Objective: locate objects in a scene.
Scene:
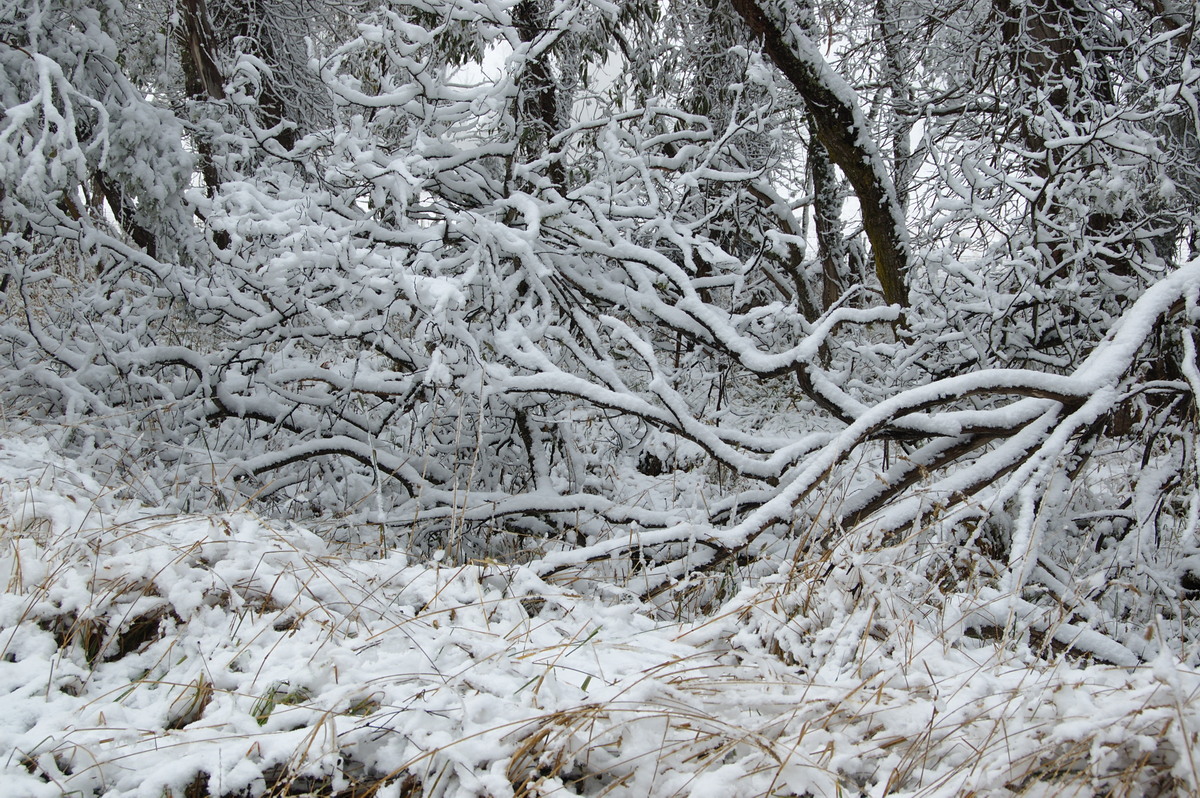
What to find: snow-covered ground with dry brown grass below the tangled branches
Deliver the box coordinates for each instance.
[0,437,1200,798]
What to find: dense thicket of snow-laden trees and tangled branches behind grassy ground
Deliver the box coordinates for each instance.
[0,0,1200,661]
